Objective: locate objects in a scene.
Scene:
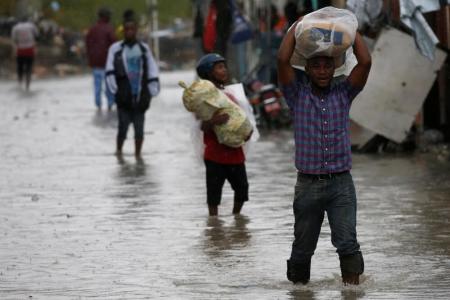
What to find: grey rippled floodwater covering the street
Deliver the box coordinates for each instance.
[0,72,450,299]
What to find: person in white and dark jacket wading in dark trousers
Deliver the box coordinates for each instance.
[106,11,160,158]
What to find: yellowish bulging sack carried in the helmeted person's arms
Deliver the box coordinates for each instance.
[179,79,253,148]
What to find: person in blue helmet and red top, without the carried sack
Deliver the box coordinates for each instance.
[197,53,248,216]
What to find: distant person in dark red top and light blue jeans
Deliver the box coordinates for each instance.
[86,8,116,110]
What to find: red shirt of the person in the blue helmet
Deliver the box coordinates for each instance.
[203,93,245,165]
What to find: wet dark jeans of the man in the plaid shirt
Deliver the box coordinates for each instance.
[288,172,364,282]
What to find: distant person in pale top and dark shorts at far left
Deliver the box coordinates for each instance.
[11,18,38,90]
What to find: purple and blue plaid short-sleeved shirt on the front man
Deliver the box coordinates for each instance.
[281,71,360,174]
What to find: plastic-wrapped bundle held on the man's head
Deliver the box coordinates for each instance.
[291,6,358,68]
